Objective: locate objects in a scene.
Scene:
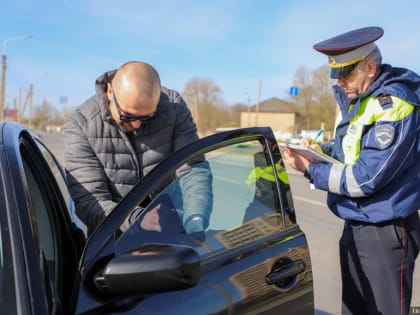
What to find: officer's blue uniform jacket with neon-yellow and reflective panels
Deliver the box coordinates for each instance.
[308,65,420,223]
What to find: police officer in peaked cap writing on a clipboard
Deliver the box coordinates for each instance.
[285,27,420,315]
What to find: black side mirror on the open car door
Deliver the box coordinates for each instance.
[94,244,200,295]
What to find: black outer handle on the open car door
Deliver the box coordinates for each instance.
[265,259,305,286]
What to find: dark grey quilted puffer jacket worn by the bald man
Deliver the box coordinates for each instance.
[64,70,205,231]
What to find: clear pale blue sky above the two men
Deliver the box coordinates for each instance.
[0,0,420,109]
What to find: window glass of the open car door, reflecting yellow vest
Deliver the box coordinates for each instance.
[116,141,288,257]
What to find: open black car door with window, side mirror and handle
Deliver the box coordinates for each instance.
[75,128,314,315]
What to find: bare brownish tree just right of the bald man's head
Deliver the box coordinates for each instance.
[182,78,230,135]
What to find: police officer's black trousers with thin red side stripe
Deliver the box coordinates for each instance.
[340,212,420,315]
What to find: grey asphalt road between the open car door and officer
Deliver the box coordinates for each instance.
[41,133,420,315]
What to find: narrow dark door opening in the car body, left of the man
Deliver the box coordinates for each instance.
[20,135,84,310]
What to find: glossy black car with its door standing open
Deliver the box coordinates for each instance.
[0,122,314,315]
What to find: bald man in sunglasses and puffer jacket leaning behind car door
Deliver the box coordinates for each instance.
[64,61,212,234]
